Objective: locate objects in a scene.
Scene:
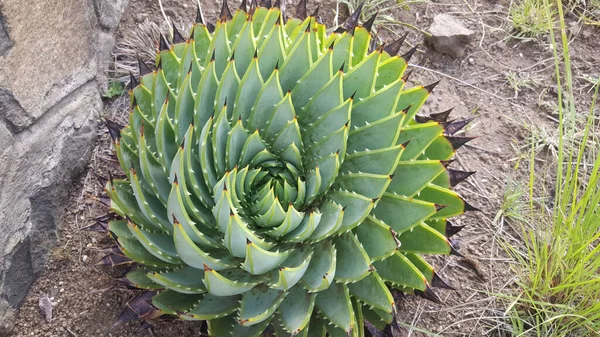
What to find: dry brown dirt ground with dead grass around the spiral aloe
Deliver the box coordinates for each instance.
[14,0,600,337]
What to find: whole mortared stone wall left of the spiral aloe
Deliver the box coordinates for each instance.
[0,0,128,335]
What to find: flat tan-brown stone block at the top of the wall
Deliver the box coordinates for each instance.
[0,0,97,122]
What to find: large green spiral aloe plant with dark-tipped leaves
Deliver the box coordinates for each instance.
[102,1,472,337]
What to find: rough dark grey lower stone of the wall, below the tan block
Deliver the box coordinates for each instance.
[0,83,102,332]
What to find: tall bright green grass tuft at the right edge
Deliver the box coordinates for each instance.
[499,0,600,337]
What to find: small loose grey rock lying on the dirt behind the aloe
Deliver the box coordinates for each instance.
[426,14,474,57]
